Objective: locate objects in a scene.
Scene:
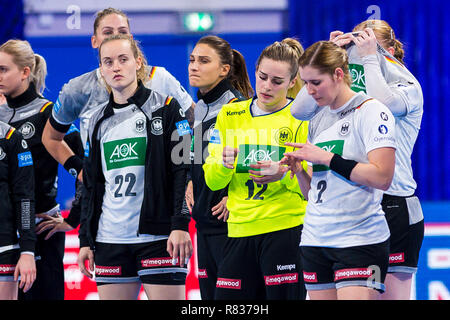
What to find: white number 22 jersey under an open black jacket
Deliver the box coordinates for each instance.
[96,105,167,243]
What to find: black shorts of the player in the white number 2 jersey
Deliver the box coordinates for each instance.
[300,240,389,292]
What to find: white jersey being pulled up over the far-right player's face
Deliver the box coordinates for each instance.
[348,45,423,197]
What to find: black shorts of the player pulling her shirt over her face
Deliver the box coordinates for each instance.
[381,194,425,273]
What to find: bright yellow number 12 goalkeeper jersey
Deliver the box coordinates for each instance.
[203,99,308,237]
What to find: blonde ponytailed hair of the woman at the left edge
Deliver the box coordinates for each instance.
[0,39,47,95]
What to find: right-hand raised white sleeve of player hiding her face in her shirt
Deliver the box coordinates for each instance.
[362,54,408,117]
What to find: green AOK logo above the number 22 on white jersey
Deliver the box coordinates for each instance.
[103,137,147,170]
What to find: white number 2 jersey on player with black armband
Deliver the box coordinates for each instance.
[301,93,395,248]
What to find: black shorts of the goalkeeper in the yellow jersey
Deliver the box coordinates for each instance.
[215,226,306,300]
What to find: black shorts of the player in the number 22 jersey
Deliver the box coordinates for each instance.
[94,240,187,285]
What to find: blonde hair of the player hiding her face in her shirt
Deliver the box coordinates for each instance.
[353,19,405,64]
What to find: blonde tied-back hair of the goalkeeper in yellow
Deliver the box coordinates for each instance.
[256,38,304,98]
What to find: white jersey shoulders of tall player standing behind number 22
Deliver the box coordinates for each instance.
[52,67,193,146]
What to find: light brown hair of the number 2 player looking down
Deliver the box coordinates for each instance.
[299,41,352,86]
